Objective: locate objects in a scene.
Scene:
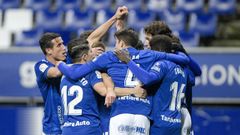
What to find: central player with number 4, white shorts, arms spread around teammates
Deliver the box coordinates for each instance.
[58,29,188,135]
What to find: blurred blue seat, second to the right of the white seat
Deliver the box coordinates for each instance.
[65,9,94,30]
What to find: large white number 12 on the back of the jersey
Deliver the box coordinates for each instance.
[61,85,83,115]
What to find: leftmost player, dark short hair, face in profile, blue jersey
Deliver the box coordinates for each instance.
[34,33,66,135]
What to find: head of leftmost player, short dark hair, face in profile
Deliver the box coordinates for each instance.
[39,33,66,61]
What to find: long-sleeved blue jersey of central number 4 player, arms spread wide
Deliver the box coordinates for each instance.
[58,48,189,116]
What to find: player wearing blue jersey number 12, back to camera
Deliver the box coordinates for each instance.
[61,40,146,135]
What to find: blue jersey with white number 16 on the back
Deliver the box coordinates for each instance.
[150,60,188,135]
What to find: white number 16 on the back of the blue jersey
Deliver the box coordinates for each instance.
[169,81,185,111]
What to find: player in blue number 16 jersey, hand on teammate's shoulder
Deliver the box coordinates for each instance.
[116,35,187,135]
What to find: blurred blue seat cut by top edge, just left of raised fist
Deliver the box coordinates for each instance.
[85,0,112,11]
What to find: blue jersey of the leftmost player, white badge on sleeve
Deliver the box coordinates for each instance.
[34,59,63,134]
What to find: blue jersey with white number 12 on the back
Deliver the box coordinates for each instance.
[60,64,102,135]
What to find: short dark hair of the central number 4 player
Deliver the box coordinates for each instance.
[115,29,139,48]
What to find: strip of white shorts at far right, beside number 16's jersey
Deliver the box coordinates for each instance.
[181,107,192,135]
